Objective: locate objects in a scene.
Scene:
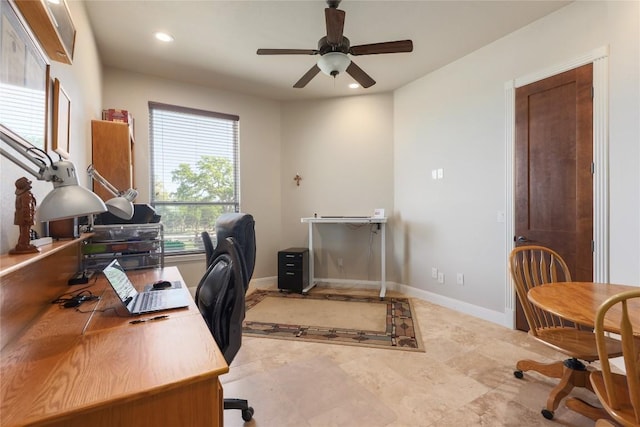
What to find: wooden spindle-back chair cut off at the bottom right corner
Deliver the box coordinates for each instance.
[590,288,640,427]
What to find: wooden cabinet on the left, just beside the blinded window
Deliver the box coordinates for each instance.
[91,120,134,201]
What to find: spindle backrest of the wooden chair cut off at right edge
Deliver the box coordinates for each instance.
[595,289,640,425]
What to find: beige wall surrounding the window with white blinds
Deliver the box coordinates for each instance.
[102,68,281,286]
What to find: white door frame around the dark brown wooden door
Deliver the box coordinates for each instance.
[503,46,609,329]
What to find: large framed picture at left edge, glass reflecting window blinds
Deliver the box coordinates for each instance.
[0,0,49,151]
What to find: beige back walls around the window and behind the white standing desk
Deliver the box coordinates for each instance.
[103,76,393,286]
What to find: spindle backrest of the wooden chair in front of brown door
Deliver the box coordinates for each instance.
[509,245,573,336]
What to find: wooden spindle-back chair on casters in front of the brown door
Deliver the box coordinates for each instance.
[509,245,622,420]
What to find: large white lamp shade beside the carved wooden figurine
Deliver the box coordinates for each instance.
[38,160,107,222]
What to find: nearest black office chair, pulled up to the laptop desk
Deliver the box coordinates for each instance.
[195,214,255,421]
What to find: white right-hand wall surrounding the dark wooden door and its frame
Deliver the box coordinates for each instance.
[394,1,640,320]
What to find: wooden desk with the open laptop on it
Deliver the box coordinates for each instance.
[0,267,229,427]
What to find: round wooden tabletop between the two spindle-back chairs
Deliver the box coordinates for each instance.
[527,282,640,333]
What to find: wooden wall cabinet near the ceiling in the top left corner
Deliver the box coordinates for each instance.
[15,0,76,64]
